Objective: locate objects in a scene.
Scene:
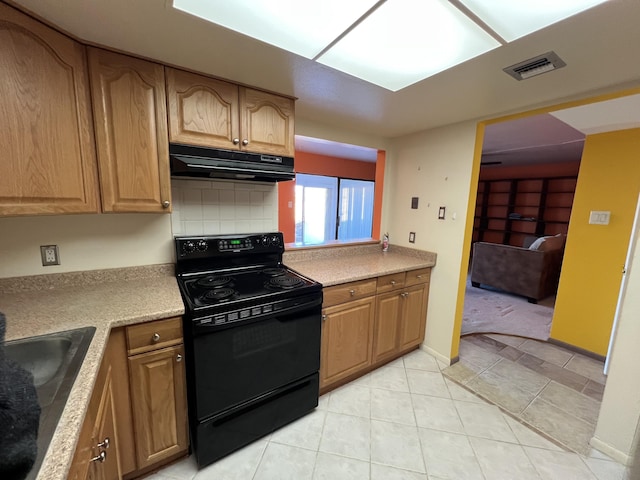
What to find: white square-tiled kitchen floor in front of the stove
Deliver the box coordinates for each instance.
[148,350,627,480]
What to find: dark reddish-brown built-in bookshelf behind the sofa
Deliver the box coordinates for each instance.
[473,176,577,246]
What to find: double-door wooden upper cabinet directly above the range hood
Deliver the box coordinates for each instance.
[166,67,294,156]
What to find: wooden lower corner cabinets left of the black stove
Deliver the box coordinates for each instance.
[68,317,189,480]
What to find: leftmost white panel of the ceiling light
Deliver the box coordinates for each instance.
[173,0,376,58]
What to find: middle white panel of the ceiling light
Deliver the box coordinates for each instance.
[317,0,500,92]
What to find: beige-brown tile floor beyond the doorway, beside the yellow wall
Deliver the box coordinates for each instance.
[443,334,606,455]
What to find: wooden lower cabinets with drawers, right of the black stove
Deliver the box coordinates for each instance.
[320,268,431,393]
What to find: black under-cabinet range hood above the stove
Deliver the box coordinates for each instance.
[169,143,295,182]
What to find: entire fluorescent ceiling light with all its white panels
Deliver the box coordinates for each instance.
[173,0,606,91]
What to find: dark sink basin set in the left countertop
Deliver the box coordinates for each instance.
[4,327,96,480]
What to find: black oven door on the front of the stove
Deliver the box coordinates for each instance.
[190,293,322,421]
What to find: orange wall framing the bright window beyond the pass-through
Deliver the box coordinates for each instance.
[278,152,384,243]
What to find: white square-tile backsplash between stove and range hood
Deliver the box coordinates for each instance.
[171,178,278,235]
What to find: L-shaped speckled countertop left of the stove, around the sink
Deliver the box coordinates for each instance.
[0,265,184,480]
